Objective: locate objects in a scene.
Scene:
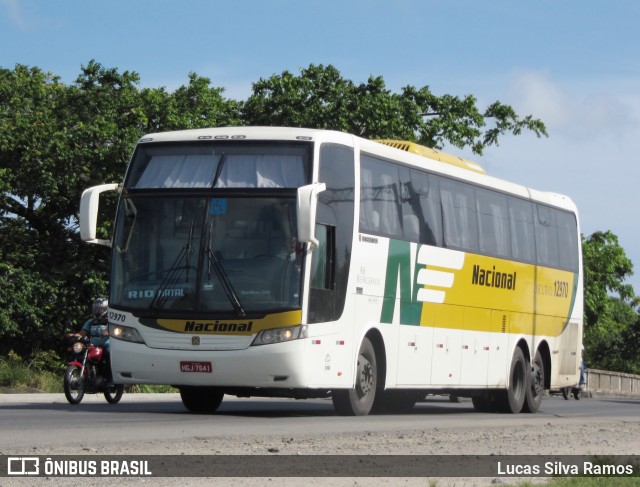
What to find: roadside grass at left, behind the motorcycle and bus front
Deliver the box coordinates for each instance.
[0,350,177,394]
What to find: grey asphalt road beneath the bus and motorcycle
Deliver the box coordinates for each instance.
[0,394,640,454]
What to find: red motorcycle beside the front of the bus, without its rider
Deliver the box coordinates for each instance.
[64,335,124,404]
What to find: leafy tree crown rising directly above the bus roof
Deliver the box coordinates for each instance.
[242,65,547,154]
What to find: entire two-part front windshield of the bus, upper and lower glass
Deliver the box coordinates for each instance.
[111,141,311,317]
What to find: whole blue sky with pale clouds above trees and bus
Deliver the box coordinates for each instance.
[0,0,640,294]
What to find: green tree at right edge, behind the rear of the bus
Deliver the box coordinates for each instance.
[582,231,640,372]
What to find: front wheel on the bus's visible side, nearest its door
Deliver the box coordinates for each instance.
[331,337,378,416]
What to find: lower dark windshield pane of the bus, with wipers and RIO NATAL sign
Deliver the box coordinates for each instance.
[111,195,301,317]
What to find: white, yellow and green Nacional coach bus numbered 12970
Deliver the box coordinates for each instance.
[80,127,583,415]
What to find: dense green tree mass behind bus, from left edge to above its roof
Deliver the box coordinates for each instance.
[0,61,560,354]
